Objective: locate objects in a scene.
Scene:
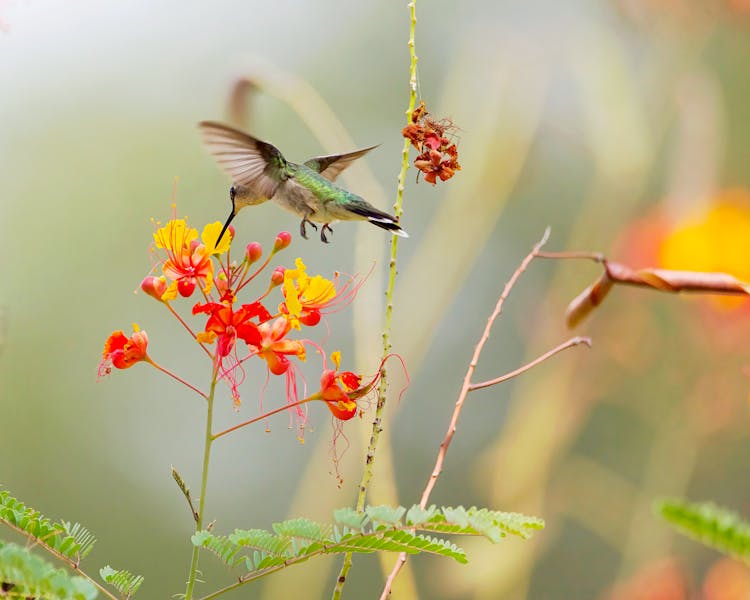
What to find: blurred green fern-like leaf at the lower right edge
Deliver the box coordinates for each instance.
[656,500,750,564]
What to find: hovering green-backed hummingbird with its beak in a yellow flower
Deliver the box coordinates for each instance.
[198,121,409,244]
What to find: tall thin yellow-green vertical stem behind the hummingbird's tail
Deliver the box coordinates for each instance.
[332,0,418,600]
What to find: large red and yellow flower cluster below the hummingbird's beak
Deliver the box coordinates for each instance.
[99,207,377,427]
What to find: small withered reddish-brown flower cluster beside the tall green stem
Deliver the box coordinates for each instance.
[401,102,461,185]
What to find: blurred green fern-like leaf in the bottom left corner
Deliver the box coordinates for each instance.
[0,542,97,600]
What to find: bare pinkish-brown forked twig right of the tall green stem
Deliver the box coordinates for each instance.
[380,227,585,600]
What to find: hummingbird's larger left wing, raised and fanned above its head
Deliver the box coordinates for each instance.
[198,121,289,198]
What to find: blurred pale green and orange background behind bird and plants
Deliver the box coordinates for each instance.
[0,0,750,599]
